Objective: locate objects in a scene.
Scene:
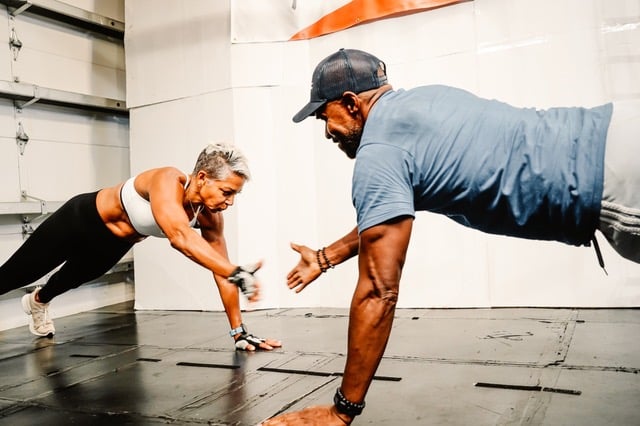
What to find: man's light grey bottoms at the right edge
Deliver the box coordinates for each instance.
[598,100,640,263]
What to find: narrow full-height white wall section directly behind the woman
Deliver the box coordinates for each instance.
[125,0,240,310]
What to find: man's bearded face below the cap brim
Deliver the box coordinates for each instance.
[316,100,363,158]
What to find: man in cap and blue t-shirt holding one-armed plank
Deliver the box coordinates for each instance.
[264,49,640,426]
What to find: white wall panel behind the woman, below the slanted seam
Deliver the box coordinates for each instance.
[131,90,244,310]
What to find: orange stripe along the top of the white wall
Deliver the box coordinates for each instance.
[289,0,472,40]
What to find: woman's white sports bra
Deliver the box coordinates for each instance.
[120,173,202,238]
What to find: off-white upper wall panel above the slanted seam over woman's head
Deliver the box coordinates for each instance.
[125,0,230,108]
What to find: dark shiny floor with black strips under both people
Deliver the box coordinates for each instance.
[0,303,640,426]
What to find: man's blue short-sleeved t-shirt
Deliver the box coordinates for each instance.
[352,86,612,245]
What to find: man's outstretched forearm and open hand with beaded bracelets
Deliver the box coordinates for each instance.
[287,227,359,293]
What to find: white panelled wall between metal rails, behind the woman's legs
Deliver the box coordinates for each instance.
[0,0,133,329]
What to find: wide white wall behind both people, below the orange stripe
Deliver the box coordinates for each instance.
[125,0,640,309]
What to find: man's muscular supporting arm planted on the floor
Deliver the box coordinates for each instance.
[263,216,413,426]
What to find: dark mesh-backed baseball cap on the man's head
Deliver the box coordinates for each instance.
[293,48,387,123]
